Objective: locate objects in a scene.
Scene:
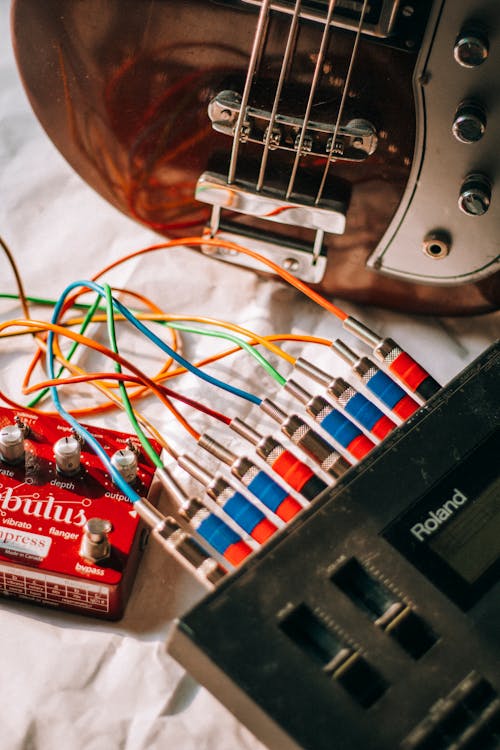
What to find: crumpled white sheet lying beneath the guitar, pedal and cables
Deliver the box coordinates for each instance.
[0,5,499,750]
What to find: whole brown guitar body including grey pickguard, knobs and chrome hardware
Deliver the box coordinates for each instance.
[12,0,500,314]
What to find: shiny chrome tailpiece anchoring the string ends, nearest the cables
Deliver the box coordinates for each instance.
[195,172,347,284]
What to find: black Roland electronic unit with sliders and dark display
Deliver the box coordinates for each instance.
[169,344,500,750]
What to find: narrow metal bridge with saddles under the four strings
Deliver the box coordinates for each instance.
[208,91,378,162]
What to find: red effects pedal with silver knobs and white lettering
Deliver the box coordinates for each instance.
[0,408,159,619]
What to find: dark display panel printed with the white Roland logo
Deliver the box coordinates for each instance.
[384,429,500,612]
